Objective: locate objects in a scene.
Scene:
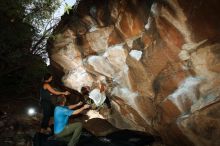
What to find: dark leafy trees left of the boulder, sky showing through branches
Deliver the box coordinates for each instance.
[0,0,60,97]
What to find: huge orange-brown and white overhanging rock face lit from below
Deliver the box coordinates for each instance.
[48,0,220,146]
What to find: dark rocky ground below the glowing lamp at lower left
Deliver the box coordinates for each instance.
[0,113,39,146]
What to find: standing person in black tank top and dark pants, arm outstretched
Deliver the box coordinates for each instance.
[40,73,70,134]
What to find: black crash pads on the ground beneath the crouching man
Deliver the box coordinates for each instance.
[33,129,155,146]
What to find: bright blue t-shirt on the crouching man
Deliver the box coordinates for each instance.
[54,106,73,134]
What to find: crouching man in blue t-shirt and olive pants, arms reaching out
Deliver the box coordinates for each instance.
[54,97,90,146]
